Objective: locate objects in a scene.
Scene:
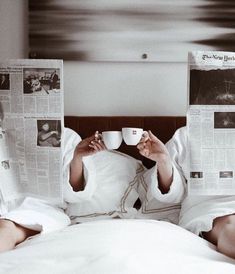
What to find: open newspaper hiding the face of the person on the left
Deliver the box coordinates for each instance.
[0,59,64,203]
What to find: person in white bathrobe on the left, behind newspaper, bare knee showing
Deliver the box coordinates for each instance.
[0,129,105,252]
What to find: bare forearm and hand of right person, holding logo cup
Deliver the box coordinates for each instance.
[137,131,173,193]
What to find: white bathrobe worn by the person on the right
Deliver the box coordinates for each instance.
[155,127,235,235]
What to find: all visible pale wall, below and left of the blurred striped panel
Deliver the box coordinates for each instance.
[0,0,187,115]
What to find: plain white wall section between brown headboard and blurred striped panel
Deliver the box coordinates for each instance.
[64,62,187,116]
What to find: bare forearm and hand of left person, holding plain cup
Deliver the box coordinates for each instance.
[69,132,105,191]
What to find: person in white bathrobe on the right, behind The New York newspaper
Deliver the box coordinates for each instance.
[138,127,235,258]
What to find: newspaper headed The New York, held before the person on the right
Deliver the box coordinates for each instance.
[187,51,235,195]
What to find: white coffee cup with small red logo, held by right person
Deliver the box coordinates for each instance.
[122,127,146,146]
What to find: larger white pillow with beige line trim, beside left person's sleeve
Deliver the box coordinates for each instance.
[66,148,144,223]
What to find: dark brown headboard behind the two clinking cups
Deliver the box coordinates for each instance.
[65,116,186,168]
